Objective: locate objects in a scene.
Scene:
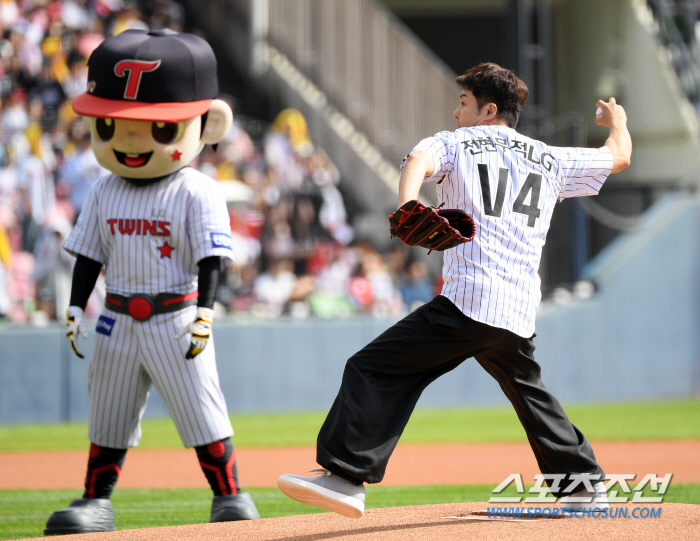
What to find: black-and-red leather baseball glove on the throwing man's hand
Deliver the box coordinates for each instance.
[389,199,476,253]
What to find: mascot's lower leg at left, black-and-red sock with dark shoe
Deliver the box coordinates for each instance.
[44,443,126,535]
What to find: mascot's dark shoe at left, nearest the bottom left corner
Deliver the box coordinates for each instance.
[44,498,115,535]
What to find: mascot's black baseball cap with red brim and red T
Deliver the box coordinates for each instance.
[73,28,219,122]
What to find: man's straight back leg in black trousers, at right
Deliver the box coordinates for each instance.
[476,329,605,497]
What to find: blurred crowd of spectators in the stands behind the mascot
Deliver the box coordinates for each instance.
[0,0,439,325]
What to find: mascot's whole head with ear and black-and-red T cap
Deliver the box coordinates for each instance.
[72,28,233,180]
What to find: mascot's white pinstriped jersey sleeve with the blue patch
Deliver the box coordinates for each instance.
[189,178,233,266]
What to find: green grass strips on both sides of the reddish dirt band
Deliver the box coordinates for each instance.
[0,400,700,541]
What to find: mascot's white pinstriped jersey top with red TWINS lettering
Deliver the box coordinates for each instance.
[64,167,232,295]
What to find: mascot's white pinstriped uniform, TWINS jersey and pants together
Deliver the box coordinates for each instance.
[64,167,233,449]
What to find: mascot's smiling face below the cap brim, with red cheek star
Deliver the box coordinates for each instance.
[90,116,204,179]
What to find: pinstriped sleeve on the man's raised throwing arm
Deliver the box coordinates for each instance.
[550,146,613,201]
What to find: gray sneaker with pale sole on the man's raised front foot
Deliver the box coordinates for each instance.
[277,469,365,518]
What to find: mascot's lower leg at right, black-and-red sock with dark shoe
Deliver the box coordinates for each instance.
[195,438,260,522]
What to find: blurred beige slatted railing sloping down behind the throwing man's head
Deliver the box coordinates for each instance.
[264,0,458,165]
